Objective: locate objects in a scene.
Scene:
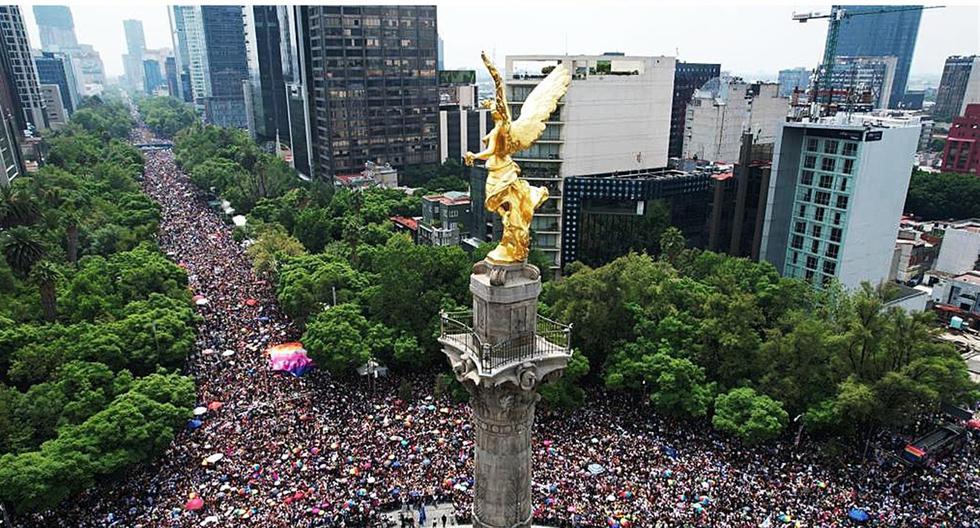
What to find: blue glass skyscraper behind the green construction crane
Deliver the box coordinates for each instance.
[827,5,922,107]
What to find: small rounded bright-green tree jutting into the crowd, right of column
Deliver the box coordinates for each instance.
[711,387,789,445]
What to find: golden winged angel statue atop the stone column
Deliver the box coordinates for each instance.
[463,52,572,264]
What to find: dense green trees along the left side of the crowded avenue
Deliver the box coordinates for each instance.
[0,98,197,513]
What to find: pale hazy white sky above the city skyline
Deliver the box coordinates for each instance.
[21,0,980,83]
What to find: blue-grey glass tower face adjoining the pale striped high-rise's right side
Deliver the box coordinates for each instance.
[201,6,248,128]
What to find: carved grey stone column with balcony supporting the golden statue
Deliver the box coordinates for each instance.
[439,262,570,528]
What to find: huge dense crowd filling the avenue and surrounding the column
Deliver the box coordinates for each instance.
[17,128,980,528]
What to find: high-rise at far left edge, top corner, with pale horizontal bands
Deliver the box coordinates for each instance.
[0,5,48,131]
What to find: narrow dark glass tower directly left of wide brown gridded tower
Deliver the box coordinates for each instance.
[243,5,292,144]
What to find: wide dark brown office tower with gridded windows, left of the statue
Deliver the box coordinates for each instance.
[301,5,439,178]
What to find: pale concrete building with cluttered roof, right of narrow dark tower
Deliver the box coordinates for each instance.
[682,79,790,163]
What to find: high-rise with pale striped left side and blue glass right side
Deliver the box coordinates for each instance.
[170,5,248,128]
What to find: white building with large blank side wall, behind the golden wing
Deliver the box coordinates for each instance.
[506,54,675,269]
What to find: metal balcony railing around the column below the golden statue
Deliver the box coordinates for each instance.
[440,310,572,374]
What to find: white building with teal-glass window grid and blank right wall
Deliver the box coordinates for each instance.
[761,114,921,288]
